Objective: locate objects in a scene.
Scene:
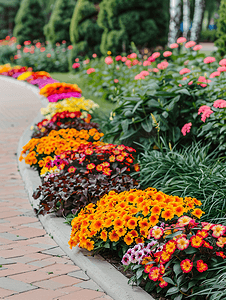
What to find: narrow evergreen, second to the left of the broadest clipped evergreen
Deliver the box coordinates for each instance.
[44,0,76,45]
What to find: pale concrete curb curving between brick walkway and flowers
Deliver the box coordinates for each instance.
[1,76,154,300]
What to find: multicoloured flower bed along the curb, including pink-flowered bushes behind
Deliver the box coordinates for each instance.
[0,38,226,300]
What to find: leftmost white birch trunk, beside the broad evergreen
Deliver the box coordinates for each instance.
[168,0,181,45]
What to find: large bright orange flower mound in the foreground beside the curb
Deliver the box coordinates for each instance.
[69,188,203,250]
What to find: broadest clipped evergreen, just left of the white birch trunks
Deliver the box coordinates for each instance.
[98,0,168,54]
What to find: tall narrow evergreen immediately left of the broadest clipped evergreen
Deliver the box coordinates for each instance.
[70,0,102,63]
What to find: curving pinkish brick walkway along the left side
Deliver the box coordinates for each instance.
[0,77,112,300]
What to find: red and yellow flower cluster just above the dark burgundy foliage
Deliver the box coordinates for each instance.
[42,141,139,176]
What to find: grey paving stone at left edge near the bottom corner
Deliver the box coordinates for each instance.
[0,277,37,292]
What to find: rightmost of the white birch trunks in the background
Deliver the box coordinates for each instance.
[191,0,205,42]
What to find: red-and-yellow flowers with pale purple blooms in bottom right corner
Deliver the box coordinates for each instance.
[122,215,226,299]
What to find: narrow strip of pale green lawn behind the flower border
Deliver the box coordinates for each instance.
[50,73,115,115]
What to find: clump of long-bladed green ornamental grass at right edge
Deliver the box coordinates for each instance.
[139,143,226,222]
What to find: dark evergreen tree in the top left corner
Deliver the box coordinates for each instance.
[0,0,20,39]
